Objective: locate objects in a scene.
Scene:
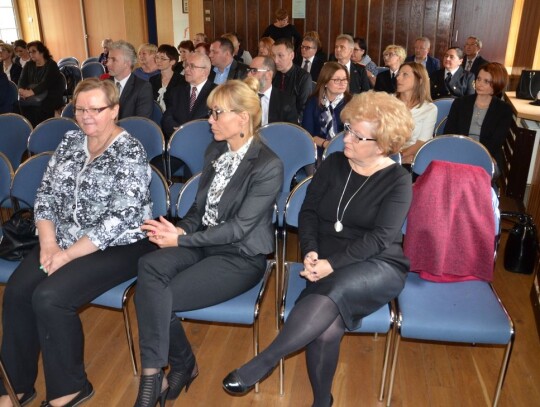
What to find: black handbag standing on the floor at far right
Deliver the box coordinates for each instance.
[501,212,538,274]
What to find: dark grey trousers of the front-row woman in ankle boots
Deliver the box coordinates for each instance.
[135,245,266,369]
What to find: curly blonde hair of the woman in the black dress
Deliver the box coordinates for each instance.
[340,90,414,155]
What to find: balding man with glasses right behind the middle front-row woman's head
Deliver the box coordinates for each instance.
[248,57,298,126]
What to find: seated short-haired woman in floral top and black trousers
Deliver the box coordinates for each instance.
[0,76,155,407]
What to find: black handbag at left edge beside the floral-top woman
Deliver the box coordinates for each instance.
[0,201,39,261]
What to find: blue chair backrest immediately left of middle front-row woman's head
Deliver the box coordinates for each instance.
[167,119,214,175]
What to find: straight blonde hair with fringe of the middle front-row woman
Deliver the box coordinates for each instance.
[206,78,262,137]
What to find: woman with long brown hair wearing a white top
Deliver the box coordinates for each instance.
[396,62,437,164]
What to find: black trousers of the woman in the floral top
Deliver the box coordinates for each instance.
[0,239,156,400]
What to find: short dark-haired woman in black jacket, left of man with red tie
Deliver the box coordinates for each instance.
[150,44,184,111]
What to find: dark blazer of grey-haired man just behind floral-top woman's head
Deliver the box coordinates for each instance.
[118,74,154,119]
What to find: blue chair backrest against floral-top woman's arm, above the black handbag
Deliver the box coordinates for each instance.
[11,152,53,207]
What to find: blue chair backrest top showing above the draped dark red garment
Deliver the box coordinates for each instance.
[412,135,493,176]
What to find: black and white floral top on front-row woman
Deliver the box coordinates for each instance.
[34,130,152,250]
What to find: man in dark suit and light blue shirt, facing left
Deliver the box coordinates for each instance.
[209,37,248,85]
